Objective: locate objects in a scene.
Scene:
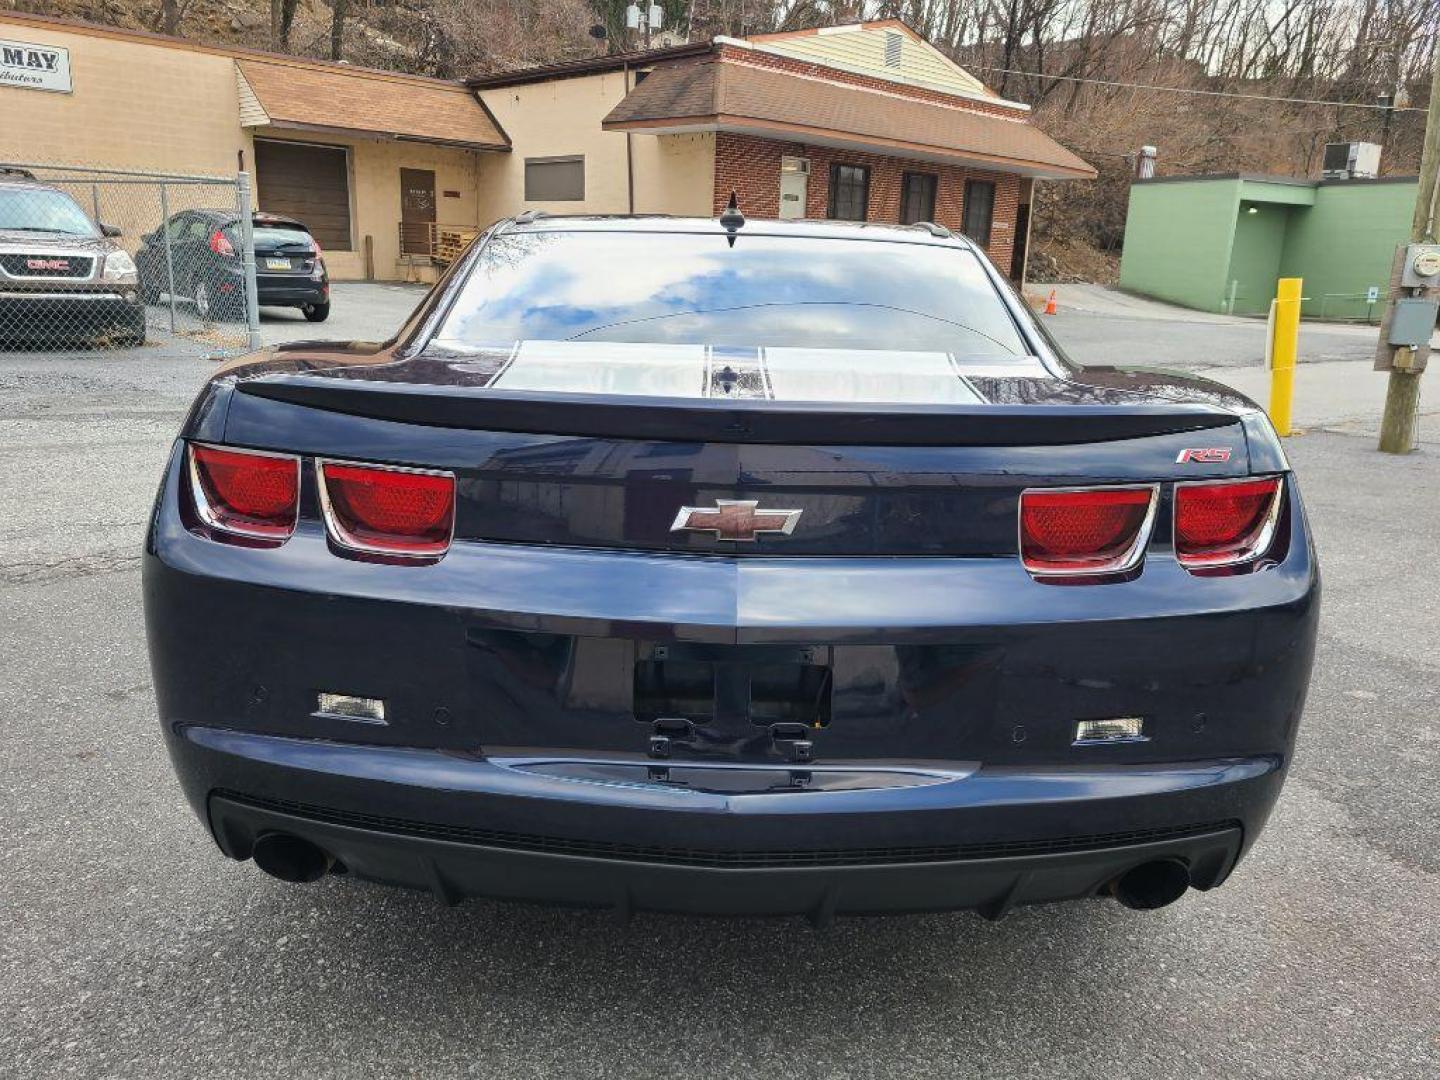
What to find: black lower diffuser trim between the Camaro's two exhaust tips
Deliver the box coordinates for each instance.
[210,795,1243,923]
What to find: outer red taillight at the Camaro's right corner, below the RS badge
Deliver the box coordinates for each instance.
[1175,477,1280,569]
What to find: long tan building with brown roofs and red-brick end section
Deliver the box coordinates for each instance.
[0,12,1094,279]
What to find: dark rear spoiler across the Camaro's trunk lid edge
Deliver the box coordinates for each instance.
[236,374,1241,446]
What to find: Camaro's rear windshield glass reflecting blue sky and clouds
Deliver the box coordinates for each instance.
[439,230,1027,356]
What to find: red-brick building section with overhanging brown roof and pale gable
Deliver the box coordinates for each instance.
[590,20,1094,279]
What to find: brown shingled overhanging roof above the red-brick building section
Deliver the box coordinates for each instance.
[603,56,1096,179]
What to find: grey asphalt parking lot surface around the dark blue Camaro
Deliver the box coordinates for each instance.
[0,287,1440,1080]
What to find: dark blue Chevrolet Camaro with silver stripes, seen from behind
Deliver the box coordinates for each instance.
[144,215,1319,922]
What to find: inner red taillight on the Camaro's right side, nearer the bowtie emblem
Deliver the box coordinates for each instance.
[1020,484,1156,576]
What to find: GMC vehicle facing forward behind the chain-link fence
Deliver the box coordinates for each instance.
[0,170,145,344]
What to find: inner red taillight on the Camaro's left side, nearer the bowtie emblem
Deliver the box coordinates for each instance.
[320,461,455,559]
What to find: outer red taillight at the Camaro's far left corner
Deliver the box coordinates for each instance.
[190,444,300,543]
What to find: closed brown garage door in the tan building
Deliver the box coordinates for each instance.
[255,138,350,251]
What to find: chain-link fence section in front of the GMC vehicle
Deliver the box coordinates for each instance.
[0,161,259,356]
